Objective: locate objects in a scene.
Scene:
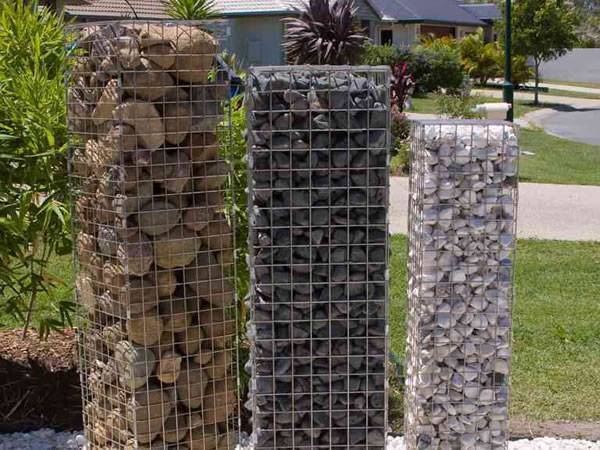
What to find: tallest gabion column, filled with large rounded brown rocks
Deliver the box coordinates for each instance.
[68,21,238,450]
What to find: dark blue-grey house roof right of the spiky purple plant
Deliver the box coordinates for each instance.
[371,0,485,26]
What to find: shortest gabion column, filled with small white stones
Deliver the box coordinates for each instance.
[405,121,519,450]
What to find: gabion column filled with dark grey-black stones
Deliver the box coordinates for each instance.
[247,66,390,450]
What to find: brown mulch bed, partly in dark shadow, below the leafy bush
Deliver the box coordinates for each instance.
[0,329,83,433]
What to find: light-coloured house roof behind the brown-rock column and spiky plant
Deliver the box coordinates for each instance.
[65,0,376,19]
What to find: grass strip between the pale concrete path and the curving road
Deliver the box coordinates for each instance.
[520,128,600,185]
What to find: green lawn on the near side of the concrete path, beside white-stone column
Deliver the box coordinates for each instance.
[390,236,600,428]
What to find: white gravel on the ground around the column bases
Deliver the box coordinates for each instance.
[0,429,600,450]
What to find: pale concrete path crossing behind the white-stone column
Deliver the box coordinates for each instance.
[390,177,600,241]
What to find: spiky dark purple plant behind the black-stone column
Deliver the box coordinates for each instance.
[283,0,368,65]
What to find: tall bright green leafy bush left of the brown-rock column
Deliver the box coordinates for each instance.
[0,0,73,334]
